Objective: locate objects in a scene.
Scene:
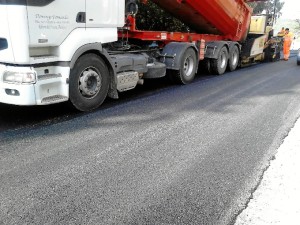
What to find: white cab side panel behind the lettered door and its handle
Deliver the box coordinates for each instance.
[86,0,125,28]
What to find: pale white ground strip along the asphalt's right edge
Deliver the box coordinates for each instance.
[235,116,300,225]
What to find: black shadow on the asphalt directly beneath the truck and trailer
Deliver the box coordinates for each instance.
[0,50,297,132]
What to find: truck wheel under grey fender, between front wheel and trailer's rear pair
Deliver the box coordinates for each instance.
[171,48,197,84]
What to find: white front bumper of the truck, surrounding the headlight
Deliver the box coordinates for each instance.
[0,64,69,105]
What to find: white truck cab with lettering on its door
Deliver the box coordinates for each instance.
[0,0,125,110]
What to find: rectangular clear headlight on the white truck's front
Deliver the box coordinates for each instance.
[3,71,36,84]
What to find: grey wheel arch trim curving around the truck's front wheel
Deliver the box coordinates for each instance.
[70,43,119,99]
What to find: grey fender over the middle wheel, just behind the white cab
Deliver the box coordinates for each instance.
[160,42,199,71]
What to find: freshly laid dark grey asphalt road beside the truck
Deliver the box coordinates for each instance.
[0,58,300,225]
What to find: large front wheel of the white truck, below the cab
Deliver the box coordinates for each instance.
[69,54,109,111]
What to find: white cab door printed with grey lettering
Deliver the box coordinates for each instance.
[27,0,85,47]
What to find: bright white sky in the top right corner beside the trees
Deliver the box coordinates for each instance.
[280,0,300,19]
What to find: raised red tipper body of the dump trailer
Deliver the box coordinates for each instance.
[151,0,252,41]
